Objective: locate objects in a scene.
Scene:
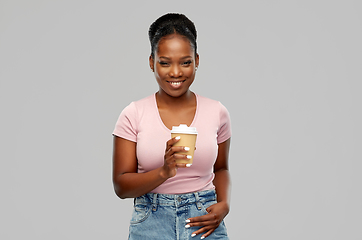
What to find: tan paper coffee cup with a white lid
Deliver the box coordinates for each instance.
[171,124,197,164]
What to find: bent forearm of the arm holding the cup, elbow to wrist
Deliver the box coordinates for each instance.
[113,168,167,199]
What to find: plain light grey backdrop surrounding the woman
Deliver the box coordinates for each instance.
[0,0,362,240]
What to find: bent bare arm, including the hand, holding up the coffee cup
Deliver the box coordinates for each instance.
[113,136,186,198]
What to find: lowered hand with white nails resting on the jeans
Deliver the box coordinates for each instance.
[186,202,229,239]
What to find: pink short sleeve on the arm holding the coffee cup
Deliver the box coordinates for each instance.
[113,102,137,142]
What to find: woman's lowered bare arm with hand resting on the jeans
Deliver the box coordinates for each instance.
[184,138,230,239]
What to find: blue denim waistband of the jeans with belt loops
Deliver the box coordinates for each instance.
[134,189,216,206]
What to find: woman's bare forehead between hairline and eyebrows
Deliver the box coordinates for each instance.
[156,34,194,57]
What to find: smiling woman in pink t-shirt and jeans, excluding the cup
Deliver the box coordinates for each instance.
[113,14,231,240]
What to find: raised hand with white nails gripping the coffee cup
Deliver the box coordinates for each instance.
[161,137,189,178]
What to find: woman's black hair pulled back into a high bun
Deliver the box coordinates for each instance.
[148,13,197,58]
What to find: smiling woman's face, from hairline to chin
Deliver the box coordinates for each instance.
[150,34,199,97]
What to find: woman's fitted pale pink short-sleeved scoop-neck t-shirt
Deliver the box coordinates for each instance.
[113,94,231,194]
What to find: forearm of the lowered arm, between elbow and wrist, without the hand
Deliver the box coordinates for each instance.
[213,169,231,207]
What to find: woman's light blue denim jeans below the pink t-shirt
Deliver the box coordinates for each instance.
[129,190,229,240]
